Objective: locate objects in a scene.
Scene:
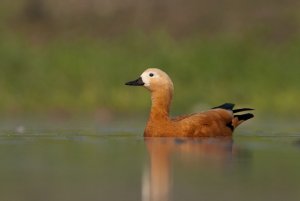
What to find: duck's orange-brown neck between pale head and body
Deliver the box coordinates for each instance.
[149,89,173,121]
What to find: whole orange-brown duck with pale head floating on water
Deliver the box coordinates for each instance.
[125,68,254,137]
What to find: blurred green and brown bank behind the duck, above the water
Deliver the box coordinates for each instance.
[0,0,300,120]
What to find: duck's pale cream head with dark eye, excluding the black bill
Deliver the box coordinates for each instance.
[141,68,174,92]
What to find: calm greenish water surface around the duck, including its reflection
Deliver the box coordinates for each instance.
[0,119,300,201]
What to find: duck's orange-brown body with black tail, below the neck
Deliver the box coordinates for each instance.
[145,104,253,137]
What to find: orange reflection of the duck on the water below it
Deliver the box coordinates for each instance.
[142,137,235,201]
